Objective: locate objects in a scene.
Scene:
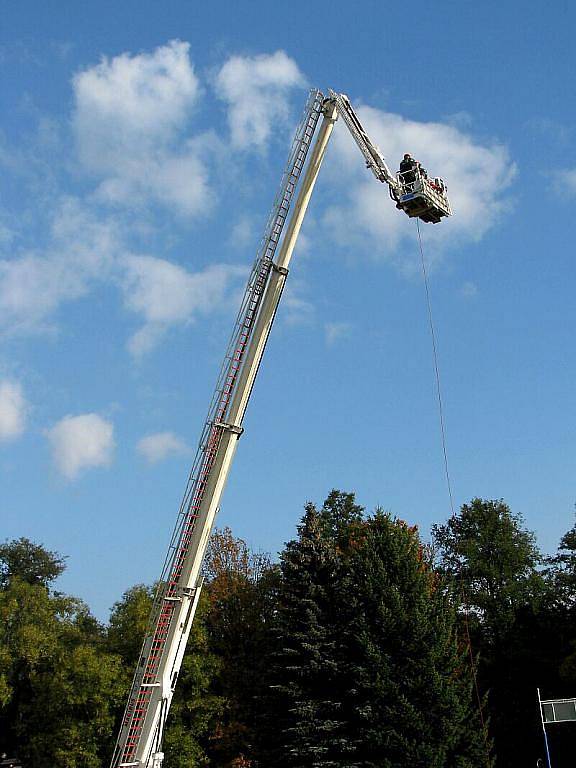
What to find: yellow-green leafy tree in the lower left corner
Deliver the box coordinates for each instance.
[0,562,124,768]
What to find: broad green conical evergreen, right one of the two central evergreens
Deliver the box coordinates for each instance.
[341,511,489,768]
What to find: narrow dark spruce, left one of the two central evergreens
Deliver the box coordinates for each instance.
[260,504,347,768]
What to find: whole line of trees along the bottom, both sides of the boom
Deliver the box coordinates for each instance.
[0,498,576,768]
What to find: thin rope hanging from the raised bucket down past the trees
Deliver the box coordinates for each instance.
[416,218,491,768]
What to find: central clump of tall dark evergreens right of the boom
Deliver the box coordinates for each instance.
[261,491,489,768]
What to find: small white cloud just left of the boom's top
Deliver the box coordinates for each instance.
[216,51,306,149]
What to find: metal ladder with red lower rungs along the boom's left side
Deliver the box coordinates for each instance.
[112,91,323,766]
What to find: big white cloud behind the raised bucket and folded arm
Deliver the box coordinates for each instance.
[324,102,515,268]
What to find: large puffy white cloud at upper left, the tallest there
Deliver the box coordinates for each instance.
[73,40,214,216]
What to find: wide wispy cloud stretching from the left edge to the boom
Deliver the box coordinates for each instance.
[0,198,246,355]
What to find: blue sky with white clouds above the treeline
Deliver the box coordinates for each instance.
[0,0,576,619]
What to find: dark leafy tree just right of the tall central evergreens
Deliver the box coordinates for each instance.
[433,498,552,765]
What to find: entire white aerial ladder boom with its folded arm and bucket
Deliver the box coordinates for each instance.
[111,90,451,768]
